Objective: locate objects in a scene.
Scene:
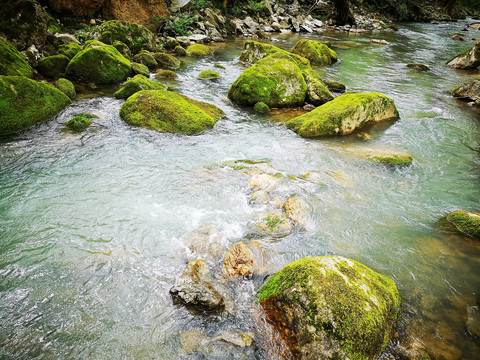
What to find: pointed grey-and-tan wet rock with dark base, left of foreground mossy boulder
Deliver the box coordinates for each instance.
[170,260,224,311]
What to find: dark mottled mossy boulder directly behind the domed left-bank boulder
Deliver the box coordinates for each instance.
[94,20,155,54]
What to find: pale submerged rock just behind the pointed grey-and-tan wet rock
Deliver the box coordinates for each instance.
[183,224,226,261]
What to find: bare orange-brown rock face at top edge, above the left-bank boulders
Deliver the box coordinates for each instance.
[102,0,170,26]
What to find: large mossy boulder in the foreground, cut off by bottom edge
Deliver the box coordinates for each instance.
[258,256,400,360]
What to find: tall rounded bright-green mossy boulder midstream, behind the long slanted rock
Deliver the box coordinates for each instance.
[228,53,307,107]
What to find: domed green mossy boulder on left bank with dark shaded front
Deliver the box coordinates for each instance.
[66,42,132,84]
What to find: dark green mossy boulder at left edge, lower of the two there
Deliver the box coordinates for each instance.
[0,75,70,135]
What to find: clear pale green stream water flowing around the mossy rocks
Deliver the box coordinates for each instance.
[0,23,480,359]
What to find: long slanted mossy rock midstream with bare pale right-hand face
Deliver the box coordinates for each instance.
[286,93,399,137]
